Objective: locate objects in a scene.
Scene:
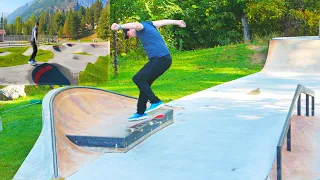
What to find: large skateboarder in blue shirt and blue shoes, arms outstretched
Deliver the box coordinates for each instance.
[111,20,186,121]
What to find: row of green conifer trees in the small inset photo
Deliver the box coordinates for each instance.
[1,0,110,39]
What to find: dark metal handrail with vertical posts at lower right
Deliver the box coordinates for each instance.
[277,84,315,180]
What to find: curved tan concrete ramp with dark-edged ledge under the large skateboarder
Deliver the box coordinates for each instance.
[14,87,172,179]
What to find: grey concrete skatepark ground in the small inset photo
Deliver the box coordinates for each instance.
[0,42,110,85]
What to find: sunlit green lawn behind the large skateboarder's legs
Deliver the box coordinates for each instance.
[92,44,262,102]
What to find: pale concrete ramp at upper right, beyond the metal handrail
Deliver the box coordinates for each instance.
[263,36,320,74]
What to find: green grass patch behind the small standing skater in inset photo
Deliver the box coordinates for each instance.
[0,47,53,67]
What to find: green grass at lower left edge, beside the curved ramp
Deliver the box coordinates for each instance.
[0,86,53,180]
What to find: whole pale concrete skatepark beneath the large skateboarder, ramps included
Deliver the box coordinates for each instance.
[11,36,320,180]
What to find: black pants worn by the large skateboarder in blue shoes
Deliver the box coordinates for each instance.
[132,54,172,114]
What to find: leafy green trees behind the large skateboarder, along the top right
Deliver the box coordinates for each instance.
[111,0,320,53]
